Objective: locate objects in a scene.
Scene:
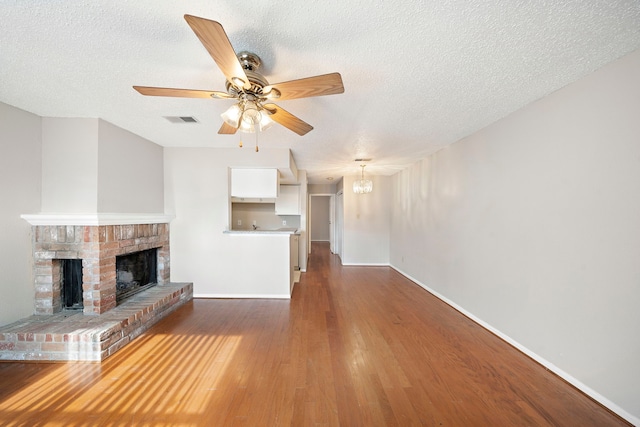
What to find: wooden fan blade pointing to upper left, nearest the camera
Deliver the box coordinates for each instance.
[184,15,251,89]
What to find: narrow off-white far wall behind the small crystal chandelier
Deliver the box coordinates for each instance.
[341,175,392,265]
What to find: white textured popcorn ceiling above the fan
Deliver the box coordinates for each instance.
[0,0,640,183]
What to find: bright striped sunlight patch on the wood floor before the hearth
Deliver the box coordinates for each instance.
[0,334,242,426]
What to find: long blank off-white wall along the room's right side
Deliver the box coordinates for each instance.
[390,51,640,423]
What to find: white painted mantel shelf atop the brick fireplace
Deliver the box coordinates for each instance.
[20,213,175,226]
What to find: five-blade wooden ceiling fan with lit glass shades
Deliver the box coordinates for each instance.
[133,15,344,135]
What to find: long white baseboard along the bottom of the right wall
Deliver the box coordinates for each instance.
[389,265,640,426]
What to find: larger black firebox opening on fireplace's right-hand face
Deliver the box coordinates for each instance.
[116,248,158,304]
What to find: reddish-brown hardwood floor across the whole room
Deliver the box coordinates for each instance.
[0,244,628,427]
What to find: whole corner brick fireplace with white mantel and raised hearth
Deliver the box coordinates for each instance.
[0,214,193,362]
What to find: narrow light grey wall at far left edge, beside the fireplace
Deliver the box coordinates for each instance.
[0,103,42,325]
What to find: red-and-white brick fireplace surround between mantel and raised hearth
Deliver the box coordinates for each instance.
[28,219,170,315]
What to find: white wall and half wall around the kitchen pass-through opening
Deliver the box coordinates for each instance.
[164,148,306,297]
